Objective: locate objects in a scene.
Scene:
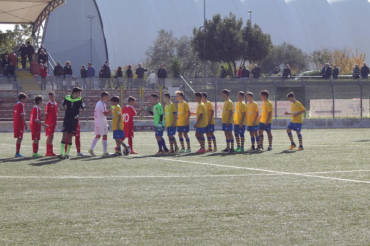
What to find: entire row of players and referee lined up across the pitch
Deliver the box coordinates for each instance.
[13,88,305,159]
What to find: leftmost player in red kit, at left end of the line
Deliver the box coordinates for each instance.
[13,93,27,158]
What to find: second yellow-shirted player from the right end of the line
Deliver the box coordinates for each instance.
[258,90,272,151]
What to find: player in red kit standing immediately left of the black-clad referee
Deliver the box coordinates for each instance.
[45,92,58,156]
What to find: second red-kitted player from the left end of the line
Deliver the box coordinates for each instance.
[30,96,42,158]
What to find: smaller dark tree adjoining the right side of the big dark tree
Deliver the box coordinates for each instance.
[242,20,272,63]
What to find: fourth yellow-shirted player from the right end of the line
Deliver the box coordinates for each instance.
[234,91,246,153]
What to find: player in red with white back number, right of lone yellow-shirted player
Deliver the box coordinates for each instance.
[122,97,137,154]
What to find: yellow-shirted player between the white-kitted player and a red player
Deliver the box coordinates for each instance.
[110,96,130,156]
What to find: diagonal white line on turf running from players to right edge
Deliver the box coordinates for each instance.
[152,157,370,184]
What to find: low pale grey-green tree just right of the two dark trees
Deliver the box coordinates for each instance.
[261,43,308,73]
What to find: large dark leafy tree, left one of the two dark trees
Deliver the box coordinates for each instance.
[192,13,243,76]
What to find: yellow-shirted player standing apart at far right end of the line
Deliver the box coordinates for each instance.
[285,92,306,151]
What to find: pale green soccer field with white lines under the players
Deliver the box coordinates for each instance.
[0,129,370,245]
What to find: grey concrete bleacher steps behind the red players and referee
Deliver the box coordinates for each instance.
[0,89,163,121]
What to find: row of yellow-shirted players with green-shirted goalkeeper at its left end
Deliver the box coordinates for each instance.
[151,89,306,154]
